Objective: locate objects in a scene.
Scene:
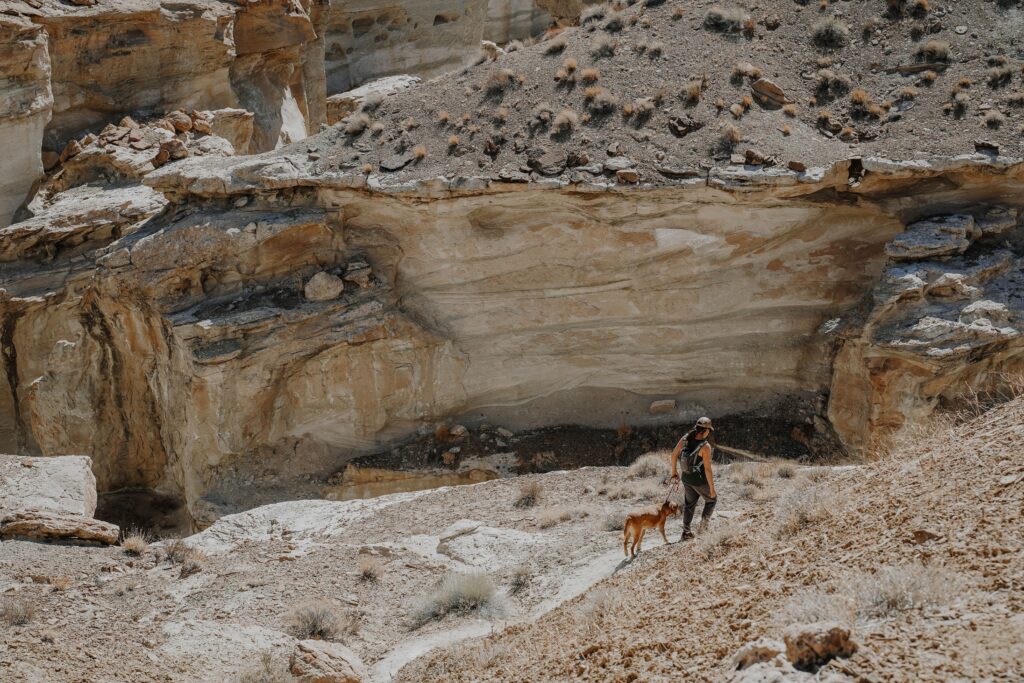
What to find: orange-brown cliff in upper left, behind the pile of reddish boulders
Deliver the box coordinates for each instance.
[0,0,327,226]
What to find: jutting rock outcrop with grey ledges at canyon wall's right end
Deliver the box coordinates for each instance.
[828,207,1024,450]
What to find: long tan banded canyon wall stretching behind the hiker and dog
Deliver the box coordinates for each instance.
[0,144,1024,514]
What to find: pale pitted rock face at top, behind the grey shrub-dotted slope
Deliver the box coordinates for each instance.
[326,0,488,93]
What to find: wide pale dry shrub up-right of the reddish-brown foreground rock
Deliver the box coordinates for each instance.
[842,564,961,618]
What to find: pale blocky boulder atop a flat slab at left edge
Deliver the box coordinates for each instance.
[0,456,96,517]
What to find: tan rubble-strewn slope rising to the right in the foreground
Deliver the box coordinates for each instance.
[399,399,1024,681]
